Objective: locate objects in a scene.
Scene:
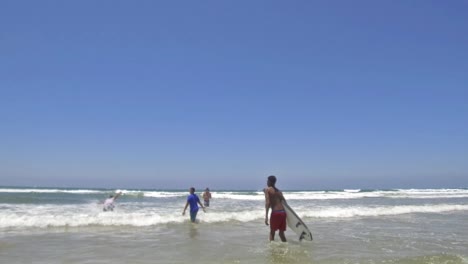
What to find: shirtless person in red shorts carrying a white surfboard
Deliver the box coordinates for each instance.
[263,175,286,242]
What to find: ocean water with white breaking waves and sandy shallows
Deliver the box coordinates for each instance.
[0,187,468,264]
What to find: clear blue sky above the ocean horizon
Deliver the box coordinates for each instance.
[0,0,468,189]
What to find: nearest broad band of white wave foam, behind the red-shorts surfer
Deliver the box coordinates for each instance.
[0,204,468,228]
